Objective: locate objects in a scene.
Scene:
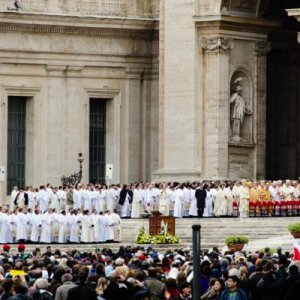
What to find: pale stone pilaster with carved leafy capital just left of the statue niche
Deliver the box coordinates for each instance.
[201,37,233,179]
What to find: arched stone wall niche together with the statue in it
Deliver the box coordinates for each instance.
[229,69,255,144]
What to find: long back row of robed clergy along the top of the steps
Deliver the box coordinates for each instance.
[5,180,300,218]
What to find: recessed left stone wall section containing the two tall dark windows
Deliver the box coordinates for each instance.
[0,1,158,202]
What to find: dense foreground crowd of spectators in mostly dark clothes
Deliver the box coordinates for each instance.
[0,244,300,300]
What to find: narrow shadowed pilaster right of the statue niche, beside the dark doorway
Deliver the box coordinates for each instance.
[254,40,271,179]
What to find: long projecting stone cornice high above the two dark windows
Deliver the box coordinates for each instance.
[0,13,158,40]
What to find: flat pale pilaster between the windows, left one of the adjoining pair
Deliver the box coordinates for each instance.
[44,65,66,184]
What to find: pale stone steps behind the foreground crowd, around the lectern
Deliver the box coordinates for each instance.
[7,217,300,251]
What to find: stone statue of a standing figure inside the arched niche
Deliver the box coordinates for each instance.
[230,77,253,142]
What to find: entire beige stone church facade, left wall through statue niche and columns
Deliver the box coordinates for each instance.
[0,0,300,202]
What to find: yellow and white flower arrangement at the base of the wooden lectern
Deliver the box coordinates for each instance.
[136,226,179,244]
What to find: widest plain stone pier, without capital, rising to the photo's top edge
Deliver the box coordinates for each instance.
[153,0,202,181]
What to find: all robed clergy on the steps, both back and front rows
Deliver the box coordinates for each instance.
[0,180,300,243]
